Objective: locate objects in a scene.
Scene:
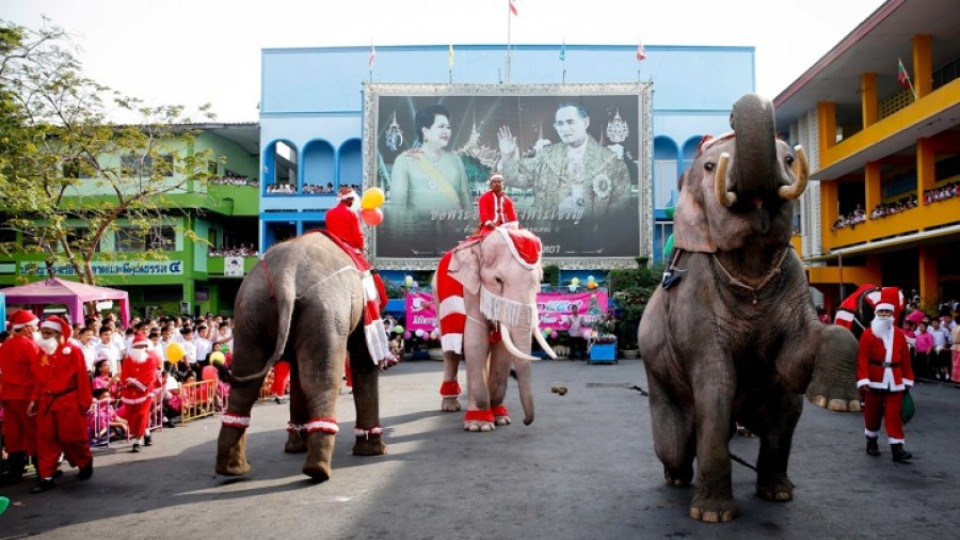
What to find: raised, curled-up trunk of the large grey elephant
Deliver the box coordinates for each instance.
[730,94,776,194]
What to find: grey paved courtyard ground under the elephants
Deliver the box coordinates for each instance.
[0,360,960,539]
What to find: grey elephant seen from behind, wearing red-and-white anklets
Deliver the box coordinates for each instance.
[216,232,387,482]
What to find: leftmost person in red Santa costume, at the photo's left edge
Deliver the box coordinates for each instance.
[0,310,41,484]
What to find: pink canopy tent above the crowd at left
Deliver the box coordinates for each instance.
[0,278,130,326]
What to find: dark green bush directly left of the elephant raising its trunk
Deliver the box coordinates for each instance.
[608,257,663,349]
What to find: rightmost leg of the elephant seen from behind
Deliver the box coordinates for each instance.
[350,342,387,456]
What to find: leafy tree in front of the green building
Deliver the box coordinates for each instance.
[0,16,212,284]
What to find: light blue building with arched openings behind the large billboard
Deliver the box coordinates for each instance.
[260,44,755,278]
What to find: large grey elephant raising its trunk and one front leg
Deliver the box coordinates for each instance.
[637,94,860,522]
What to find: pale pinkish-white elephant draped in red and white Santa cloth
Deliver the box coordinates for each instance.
[432,224,556,432]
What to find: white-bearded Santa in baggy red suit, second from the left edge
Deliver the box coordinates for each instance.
[27,316,93,493]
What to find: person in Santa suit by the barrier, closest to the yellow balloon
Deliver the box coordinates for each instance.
[120,334,161,452]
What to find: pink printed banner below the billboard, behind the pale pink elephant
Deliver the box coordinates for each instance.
[404,289,609,332]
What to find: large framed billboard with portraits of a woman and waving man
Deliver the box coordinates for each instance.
[363,83,652,269]
